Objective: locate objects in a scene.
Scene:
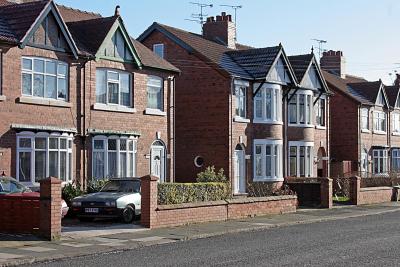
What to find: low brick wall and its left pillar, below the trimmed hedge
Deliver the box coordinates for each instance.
[141,176,297,228]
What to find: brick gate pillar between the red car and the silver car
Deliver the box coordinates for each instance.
[39,177,61,241]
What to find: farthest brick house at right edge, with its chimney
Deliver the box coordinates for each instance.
[321,51,400,177]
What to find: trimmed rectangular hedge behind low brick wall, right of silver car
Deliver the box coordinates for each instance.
[158,182,231,205]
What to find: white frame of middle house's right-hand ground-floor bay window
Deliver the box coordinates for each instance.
[288,141,314,177]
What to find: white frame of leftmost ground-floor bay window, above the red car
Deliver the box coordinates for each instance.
[16,131,74,186]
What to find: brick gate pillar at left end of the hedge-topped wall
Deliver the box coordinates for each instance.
[140,175,158,228]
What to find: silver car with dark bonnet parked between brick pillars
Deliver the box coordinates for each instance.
[72,178,141,223]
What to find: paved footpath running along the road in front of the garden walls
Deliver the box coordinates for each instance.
[0,202,400,266]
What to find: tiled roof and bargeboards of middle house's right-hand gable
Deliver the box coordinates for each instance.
[288,53,329,93]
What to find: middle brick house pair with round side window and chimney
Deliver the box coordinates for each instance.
[138,12,330,194]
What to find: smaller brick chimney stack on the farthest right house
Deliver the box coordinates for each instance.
[320,50,346,79]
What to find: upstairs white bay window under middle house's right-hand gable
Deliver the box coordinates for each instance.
[288,90,314,126]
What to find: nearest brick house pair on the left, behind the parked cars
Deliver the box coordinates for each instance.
[0,0,179,189]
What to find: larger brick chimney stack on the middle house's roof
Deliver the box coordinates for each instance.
[203,12,236,49]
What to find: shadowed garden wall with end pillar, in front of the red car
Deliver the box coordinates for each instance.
[0,178,61,240]
